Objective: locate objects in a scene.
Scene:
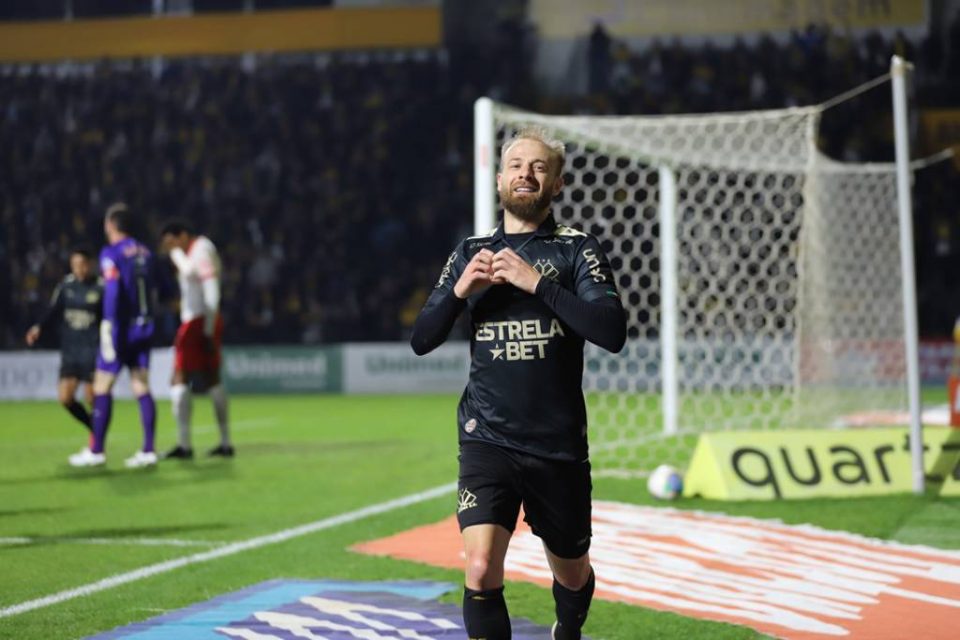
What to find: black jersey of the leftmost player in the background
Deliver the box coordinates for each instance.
[37,274,103,363]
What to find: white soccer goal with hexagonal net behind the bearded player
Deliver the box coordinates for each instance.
[475,57,919,484]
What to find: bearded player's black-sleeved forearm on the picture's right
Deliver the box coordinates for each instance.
[536,278,627,353]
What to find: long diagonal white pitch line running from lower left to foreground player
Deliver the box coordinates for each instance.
[0,482,457,618]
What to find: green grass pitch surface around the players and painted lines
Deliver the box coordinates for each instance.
[0,391,960,640]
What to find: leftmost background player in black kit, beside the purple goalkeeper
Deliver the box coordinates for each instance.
[25,247,103,442]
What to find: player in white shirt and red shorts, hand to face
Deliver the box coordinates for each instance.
[161,220,234,459]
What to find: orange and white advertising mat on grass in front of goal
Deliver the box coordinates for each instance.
[353,501,960,640]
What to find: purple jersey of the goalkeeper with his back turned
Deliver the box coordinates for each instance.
[100,238,157,364]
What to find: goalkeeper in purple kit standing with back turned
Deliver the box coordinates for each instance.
[70,203,157,467]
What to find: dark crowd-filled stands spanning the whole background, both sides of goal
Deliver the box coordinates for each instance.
[0,0,960,349]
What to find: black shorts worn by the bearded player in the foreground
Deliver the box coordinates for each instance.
[457,442,593,558]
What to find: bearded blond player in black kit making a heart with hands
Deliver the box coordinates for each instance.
[411,129,626,640]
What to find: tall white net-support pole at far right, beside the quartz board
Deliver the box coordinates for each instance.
[890,56,925,494]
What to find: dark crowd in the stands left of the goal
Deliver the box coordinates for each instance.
[0,53,470,347]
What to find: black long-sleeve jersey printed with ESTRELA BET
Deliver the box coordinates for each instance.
[411,215,626,460]
